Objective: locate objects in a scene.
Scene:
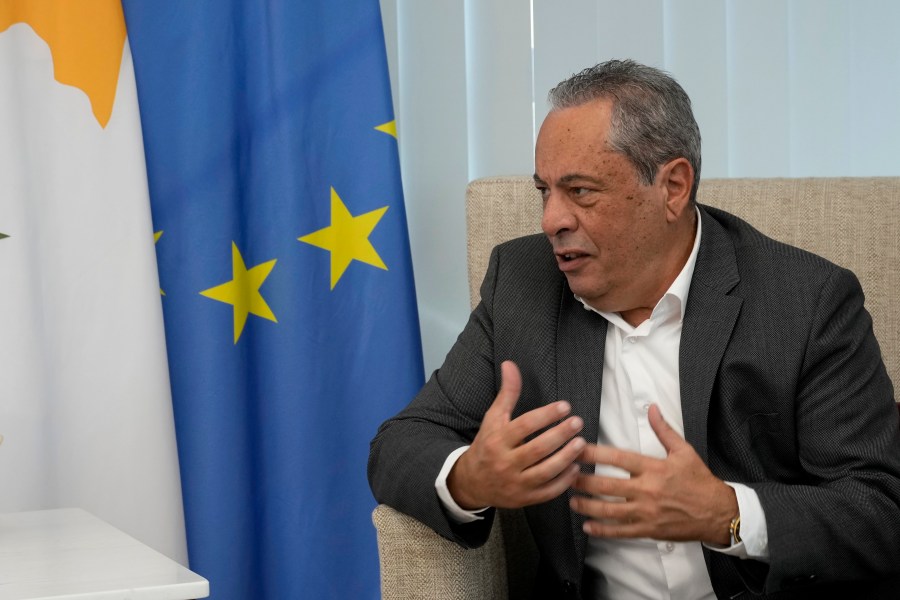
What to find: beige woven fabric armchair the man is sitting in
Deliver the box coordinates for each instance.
[373,176,900,600]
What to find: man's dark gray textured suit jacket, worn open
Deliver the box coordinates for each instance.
[369,207,900,598]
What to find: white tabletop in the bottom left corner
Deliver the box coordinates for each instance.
[0,508,209,600]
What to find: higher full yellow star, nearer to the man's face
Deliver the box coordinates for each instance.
[297,188,388,289]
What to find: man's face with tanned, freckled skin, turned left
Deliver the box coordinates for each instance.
[535,100,684,320]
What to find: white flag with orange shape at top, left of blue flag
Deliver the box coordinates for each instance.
[0,0,186,563]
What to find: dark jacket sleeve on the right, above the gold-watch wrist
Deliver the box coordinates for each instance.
[750,268,900,593]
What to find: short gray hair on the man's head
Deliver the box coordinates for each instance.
[548,60,700,202]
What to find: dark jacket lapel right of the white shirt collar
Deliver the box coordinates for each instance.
[679,206,743,462]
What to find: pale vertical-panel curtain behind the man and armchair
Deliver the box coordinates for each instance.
[382,0,900,371]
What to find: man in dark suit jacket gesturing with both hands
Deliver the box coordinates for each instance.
[369,61,900,600]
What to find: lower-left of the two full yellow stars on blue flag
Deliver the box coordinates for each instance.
[200,242,278,344]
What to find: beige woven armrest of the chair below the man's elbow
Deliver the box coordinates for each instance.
[372,504,507,600]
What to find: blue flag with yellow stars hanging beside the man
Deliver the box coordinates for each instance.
[124,0,423,600]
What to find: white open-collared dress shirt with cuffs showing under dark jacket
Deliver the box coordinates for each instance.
[435,211,768,600]
